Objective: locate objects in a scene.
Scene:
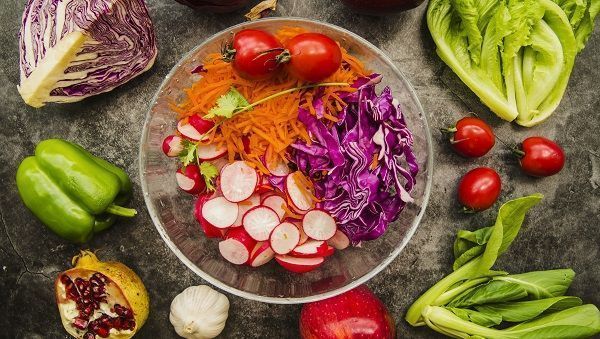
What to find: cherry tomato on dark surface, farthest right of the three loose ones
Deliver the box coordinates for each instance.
[517,137,565,177]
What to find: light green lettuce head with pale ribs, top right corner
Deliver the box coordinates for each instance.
[427,0,600,126]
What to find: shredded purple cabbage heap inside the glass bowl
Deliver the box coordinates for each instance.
[292,74,419,245]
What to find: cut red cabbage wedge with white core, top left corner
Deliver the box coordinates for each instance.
[19,0,157,107]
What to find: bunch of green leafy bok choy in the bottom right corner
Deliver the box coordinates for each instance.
[406,194,600,339]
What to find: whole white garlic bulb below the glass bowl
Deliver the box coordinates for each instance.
[169,285,229,339]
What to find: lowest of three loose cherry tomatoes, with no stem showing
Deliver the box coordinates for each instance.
[458,167,502,211]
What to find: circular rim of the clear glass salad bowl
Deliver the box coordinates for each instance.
[138,17,434,304]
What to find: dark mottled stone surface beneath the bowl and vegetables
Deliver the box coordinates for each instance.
[0,0,600,338]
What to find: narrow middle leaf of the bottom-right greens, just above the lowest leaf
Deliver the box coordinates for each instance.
[475,297,581,322]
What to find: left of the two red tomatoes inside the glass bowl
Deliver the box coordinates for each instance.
[223,29,283,80]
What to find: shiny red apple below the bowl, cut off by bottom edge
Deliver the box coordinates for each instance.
[300,285,396,339]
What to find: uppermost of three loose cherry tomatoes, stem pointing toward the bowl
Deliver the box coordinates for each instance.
[443,117,496,158]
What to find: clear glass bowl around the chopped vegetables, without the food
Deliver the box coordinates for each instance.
[139,18,433,304]
